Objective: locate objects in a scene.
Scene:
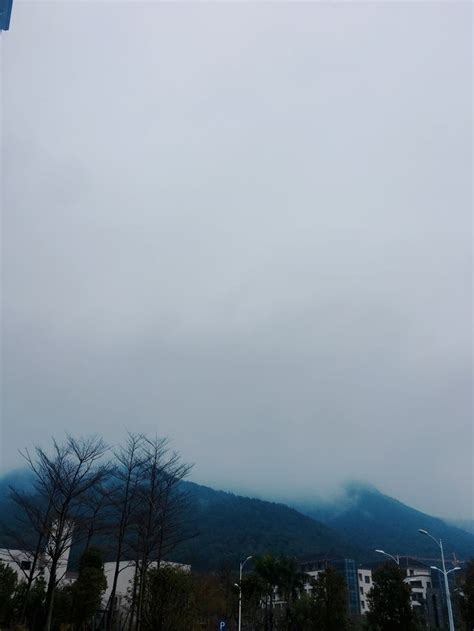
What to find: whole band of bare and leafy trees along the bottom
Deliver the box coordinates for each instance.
[0,433,474,631]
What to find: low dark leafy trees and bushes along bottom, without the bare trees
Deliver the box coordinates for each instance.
[0,547,474,631]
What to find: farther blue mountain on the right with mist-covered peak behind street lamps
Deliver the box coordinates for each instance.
[294,483,474,559]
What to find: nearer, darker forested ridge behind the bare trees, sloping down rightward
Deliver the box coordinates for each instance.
[0,471,363,570]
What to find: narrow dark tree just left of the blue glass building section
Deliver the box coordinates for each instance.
[312,566,348,631]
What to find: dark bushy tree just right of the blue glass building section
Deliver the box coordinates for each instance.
[367,563,418,631]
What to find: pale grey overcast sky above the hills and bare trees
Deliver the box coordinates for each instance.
[2,2,473,516]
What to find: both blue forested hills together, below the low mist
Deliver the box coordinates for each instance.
[0,470,474,570]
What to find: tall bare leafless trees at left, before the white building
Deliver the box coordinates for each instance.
[1,433,193,631]
